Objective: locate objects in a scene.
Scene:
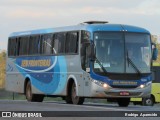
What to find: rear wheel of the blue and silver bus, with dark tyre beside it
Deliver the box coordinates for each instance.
[26,81,44,102]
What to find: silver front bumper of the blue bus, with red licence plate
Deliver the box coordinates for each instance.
[92,83,151,98]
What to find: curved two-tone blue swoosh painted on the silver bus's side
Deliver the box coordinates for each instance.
[15,56,67,94]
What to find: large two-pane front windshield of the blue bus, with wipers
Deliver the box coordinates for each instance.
[94,32,151,73]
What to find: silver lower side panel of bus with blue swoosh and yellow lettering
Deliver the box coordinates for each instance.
[6,55,84,96]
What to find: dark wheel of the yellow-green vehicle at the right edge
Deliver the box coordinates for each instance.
[142,95,155,106]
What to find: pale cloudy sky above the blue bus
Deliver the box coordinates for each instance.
[0,0,160,50]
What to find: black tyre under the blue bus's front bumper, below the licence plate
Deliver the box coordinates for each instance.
[117,98,130,107]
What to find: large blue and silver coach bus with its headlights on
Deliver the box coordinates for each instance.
[5,21,157,107]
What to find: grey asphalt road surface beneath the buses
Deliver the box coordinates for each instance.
[0,100,160,120]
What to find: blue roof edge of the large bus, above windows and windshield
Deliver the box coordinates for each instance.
[10,24,150,37]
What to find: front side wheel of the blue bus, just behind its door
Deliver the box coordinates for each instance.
[71,82,84,105]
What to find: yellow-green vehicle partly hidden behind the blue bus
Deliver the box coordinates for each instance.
[131,66,160,106]
